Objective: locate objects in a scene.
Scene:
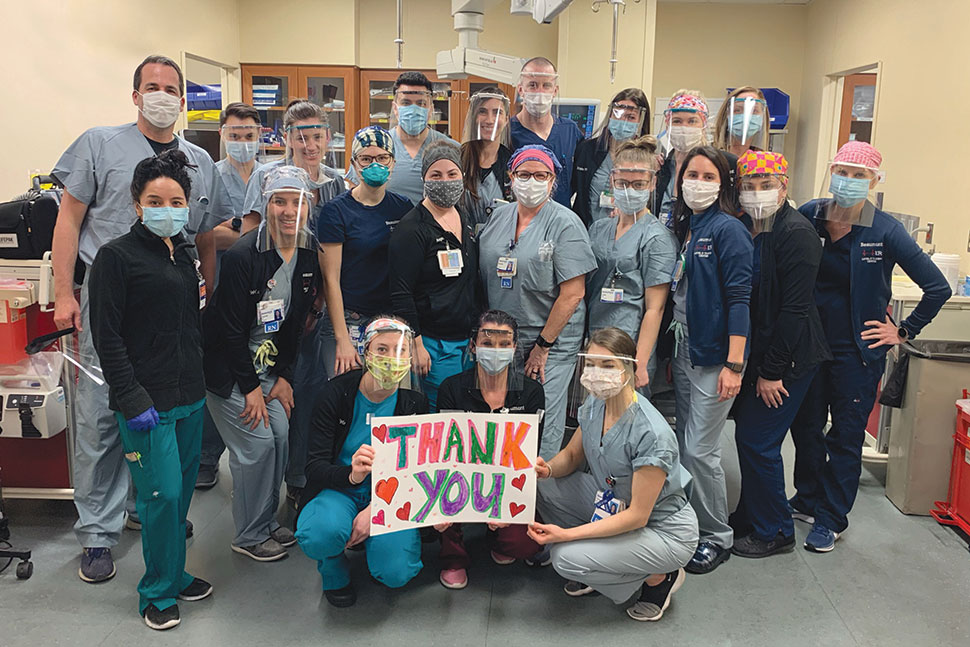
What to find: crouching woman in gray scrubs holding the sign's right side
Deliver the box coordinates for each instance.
[529,328,698,621]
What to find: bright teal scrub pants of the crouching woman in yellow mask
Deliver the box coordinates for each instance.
[296,487,424,591]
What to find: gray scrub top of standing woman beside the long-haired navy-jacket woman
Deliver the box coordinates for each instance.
[586,213,677,341]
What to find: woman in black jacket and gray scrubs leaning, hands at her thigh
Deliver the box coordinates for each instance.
[204,166,320,562]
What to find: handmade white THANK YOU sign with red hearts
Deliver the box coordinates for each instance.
[371,413,539,535]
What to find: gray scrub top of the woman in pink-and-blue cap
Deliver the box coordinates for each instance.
[478,199,596,355]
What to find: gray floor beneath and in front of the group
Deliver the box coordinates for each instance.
[0,426,970,647]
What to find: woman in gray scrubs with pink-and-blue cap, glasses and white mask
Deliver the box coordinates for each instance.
[479,145,596,458]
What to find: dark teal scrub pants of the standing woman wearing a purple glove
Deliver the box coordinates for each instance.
[115,399,205,613]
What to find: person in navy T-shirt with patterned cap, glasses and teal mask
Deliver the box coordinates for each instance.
[315,126,414,379]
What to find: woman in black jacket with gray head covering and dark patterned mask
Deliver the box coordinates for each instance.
[388,142,481,411]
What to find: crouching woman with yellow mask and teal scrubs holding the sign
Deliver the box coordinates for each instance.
[296,317,428,607]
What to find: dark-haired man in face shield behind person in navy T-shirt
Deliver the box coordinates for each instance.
[347,72,458,204]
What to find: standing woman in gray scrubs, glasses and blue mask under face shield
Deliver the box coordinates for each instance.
[586,135,677,397]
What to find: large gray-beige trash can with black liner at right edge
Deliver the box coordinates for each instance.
[886,340,970,515]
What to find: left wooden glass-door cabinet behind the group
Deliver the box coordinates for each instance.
[242,65,359,169]
